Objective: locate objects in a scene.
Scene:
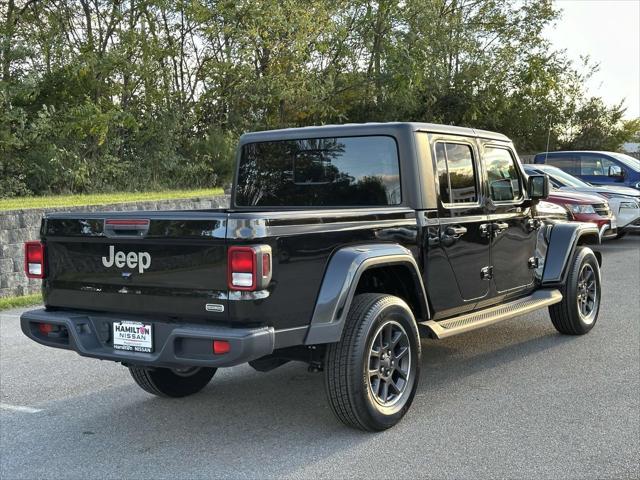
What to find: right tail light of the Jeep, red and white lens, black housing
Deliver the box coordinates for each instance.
[227,245,271,292]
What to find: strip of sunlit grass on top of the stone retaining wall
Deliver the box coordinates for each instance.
[0,188,223,212]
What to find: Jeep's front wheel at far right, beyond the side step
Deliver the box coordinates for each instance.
[549,247,601,335]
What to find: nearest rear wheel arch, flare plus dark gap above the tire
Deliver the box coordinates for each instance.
[305,244,430,345]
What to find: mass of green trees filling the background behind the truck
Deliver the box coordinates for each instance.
[0,0,637,197]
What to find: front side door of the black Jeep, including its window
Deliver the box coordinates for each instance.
[483,142,537,294]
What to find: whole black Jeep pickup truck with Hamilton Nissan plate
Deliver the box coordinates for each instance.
[21,123,601,430]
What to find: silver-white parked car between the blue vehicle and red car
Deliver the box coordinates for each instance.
[524,165,640,238]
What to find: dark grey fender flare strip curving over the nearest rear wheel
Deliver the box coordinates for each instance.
[304,244,430,345]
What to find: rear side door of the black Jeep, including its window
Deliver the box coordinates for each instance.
[427,137,490,317]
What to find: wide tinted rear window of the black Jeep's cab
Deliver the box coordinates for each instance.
[236,136,402,207]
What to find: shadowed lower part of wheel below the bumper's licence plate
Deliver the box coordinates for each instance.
[129,365,217,398]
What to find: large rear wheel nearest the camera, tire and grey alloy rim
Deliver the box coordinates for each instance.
[325,293,421,431]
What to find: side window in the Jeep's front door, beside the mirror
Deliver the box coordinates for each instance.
[484,147,522,202]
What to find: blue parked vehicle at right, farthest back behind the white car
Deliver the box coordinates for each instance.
[533,151,640,190]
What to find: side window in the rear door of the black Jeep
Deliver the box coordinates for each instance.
[436,142,478,204]
